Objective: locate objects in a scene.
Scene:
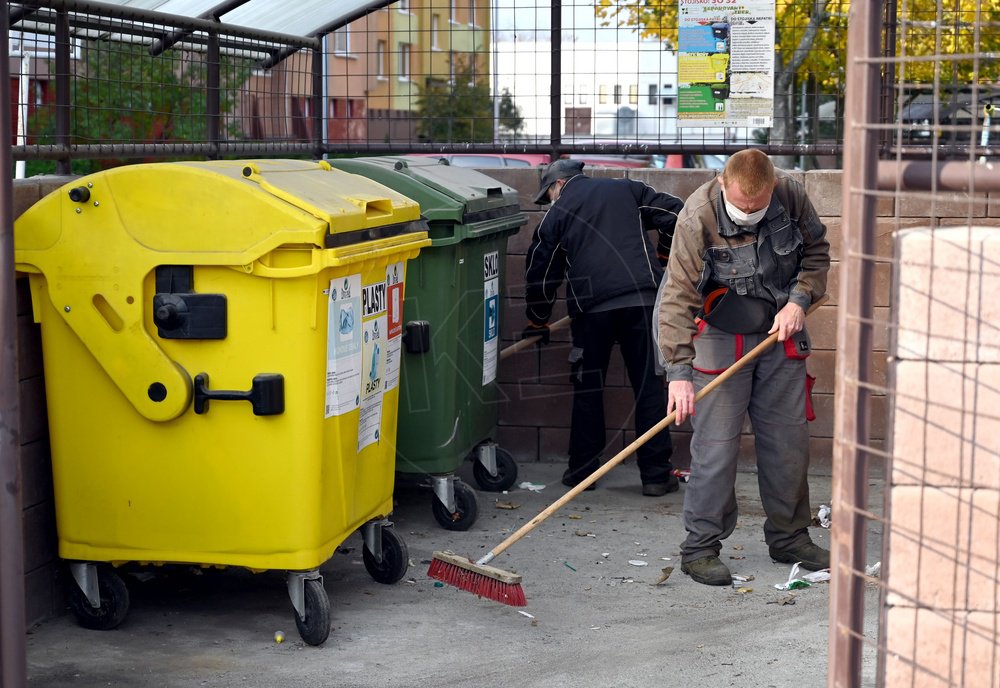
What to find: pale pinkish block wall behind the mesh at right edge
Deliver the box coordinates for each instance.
[883,228,1000,687]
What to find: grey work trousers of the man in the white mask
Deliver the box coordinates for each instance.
[681,326,812,563]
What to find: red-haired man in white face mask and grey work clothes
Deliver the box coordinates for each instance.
[658,149,830,585]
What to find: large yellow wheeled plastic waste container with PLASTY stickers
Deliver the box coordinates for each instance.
[15,160,430,645]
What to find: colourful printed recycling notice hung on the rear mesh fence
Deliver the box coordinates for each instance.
[677,0,775,128]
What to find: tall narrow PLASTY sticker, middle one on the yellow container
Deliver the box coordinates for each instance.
[358,282,388,452]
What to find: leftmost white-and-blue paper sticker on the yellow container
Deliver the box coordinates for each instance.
[324,275,361,418]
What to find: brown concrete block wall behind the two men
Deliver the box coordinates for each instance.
[482,168,896,473]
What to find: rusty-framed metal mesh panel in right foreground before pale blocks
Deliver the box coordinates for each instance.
[829,0,1000,687]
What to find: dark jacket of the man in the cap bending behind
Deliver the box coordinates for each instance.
[525,174,684,324]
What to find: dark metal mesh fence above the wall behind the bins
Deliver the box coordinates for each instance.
[9,0,847,169]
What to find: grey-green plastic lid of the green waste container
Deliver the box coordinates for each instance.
[331,156,520,224]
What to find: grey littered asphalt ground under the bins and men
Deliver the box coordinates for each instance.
[28,462,881,688]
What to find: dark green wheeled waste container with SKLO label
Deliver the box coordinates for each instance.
[330,156,527,530]
